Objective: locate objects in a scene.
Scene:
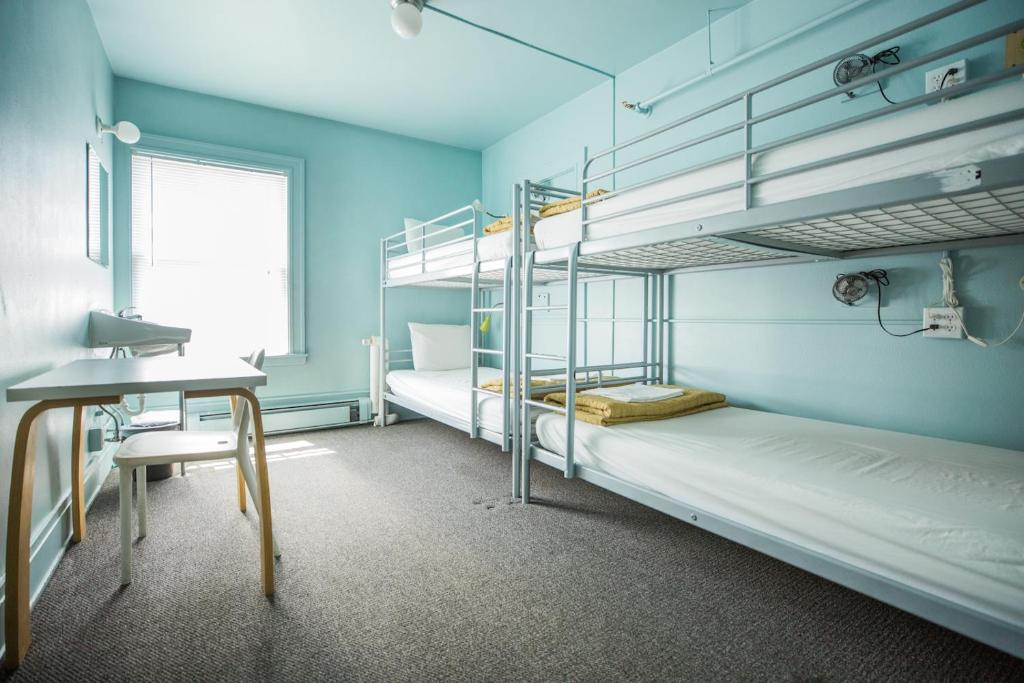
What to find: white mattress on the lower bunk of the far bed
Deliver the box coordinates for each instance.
[387,368,504,434]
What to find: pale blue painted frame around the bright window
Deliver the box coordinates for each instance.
[124,134,307,366]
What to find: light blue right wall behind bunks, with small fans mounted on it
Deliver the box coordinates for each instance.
[483,0,1024,449]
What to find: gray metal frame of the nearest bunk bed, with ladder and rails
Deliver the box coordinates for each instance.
[517,0,1024,656]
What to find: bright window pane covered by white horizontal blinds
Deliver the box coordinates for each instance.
[131,143,304,356]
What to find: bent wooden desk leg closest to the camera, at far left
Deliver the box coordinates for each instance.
[4,400,50,669]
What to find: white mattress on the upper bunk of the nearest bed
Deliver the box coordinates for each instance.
[535,80,1024,249]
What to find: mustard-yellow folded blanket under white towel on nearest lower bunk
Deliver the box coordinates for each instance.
[544,384,728,427]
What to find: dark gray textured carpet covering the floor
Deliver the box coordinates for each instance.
[2,421,1024,681]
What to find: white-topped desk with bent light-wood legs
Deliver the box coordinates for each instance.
[4,356,273,668]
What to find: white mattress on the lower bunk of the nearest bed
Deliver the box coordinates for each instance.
[537,408,1024,626]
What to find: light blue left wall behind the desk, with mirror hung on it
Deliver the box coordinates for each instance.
[0,0,113,643]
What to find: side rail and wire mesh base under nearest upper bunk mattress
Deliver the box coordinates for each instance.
[537,155,1024,271]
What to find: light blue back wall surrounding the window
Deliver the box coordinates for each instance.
[115,78,481,397]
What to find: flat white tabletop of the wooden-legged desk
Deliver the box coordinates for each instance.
[7,356,266,401]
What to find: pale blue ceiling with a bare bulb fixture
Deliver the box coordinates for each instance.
[89,0,745,150]
